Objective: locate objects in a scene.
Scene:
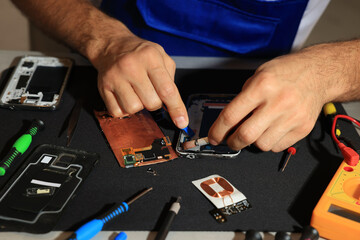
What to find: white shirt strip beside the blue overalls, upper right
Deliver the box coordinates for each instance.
[291,0,330,51]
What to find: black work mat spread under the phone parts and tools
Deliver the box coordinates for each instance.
[0,67,357,231]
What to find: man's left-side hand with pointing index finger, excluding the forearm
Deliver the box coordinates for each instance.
[93,33,188,128]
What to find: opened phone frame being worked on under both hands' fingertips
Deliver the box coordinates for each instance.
[176,94,241,158]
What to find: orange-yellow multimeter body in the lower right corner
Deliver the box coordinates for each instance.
[311,161,360,240]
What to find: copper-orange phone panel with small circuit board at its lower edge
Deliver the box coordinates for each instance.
[95,110,177,168]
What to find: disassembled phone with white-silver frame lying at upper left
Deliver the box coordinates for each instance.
[0,56,73,110]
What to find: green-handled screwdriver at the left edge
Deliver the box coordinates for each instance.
[0,119,45,176]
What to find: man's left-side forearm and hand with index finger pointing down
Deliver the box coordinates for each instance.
[12,0,189,128]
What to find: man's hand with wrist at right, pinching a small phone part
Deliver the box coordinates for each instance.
[209,40,359,152]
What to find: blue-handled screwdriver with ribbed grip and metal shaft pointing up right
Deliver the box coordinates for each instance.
[68,187,153,240]
